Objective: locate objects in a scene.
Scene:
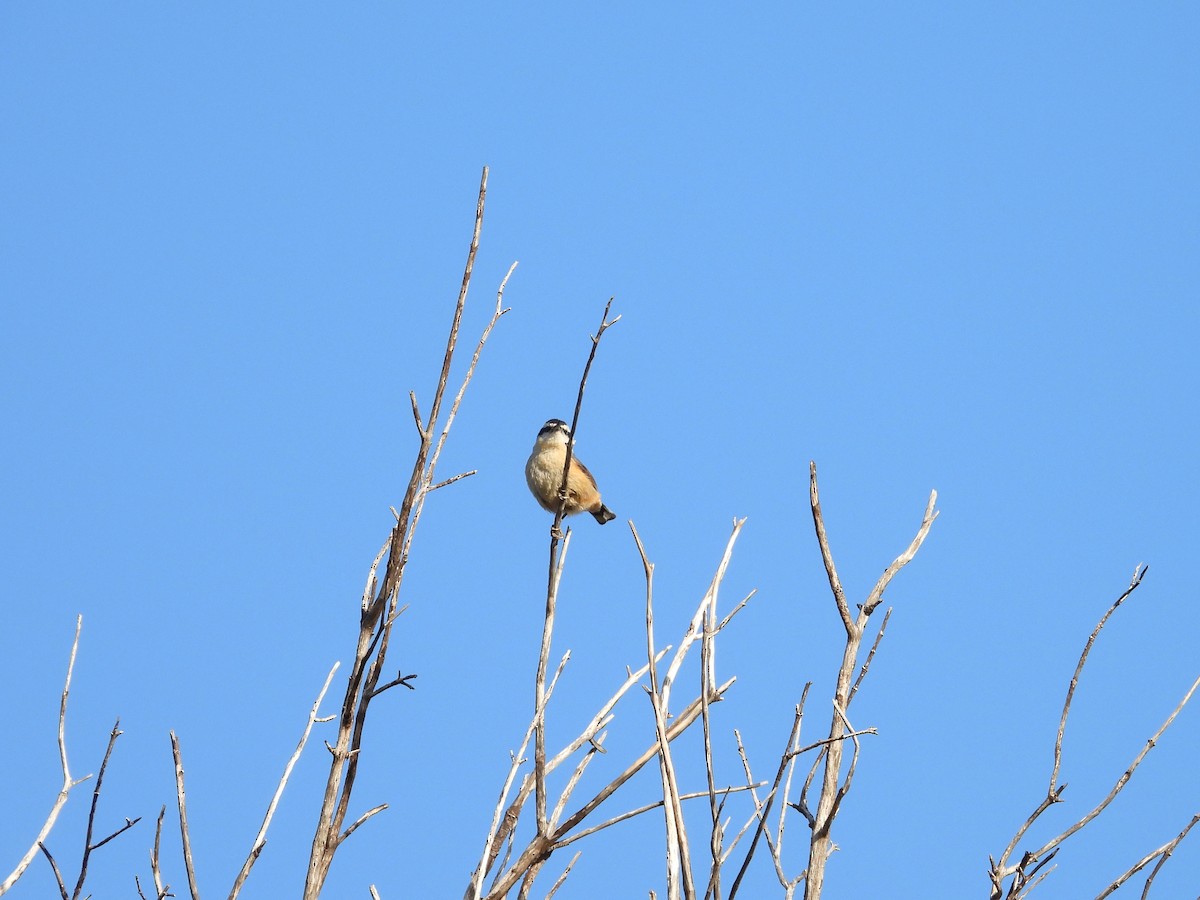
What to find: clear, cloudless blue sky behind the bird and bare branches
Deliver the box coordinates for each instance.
[0,4,1200,899]
